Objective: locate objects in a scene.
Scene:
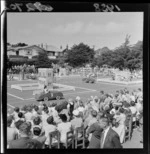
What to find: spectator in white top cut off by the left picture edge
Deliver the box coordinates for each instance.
[7,116,18,144]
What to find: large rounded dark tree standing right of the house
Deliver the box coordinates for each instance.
[66,43,94,67]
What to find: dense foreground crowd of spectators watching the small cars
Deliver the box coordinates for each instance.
[7,88,143,149]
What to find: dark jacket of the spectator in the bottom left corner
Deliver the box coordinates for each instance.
[9,137,42,149]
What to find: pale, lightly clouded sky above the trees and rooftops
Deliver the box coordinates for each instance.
[7,12,143,49]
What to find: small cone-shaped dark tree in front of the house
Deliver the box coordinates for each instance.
[35,51,52,68]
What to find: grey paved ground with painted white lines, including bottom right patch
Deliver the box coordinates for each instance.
[7,77,143,148]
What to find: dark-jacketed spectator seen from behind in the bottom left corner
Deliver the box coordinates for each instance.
[9,122,42,149]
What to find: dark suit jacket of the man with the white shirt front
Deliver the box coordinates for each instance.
[103,128,122,149]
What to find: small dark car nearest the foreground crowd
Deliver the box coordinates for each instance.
[35,91,64,101]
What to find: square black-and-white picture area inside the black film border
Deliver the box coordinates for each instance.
[0,1,148,153]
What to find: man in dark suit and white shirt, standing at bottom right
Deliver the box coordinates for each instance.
[99,118,122,149]
